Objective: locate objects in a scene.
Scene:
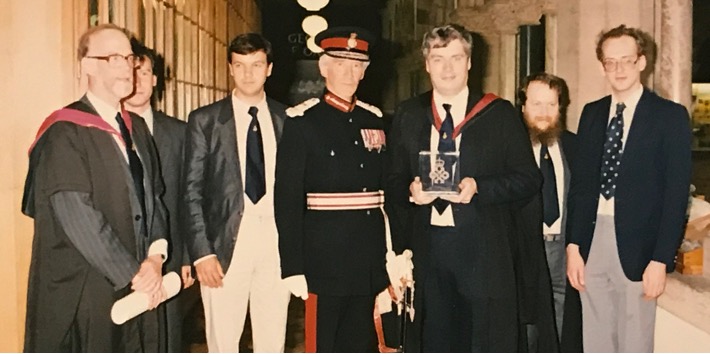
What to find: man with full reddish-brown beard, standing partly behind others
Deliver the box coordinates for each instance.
[518,73,574,351]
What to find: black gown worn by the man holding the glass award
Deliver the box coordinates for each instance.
[385,91,542,350]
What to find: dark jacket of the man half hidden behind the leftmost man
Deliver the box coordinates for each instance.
[153,110,190,272]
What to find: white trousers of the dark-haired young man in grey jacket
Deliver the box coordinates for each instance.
[201,218,291,353]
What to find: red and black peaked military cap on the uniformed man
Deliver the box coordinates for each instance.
[315,27,375,61]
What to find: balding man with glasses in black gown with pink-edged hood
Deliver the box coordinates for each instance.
[22,24,167,352]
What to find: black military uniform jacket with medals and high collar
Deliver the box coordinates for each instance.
[274,94,388,296]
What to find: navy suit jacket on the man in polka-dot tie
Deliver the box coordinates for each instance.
[567,89,692,281]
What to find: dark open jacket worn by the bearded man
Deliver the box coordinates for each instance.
[515,131,575,352]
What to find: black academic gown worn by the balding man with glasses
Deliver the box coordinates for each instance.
[22,98,165,352]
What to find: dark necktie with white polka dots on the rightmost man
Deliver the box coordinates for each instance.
[601,103,626,200]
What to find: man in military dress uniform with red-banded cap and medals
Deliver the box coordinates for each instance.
[274,27,388,352]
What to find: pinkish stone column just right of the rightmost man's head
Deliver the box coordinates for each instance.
[658,0,693,109]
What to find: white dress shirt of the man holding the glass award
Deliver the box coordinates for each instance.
[430,87,468,226]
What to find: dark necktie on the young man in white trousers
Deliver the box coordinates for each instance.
[245,106,266,204]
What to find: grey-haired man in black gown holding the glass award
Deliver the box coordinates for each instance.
[386,25,541,352]
